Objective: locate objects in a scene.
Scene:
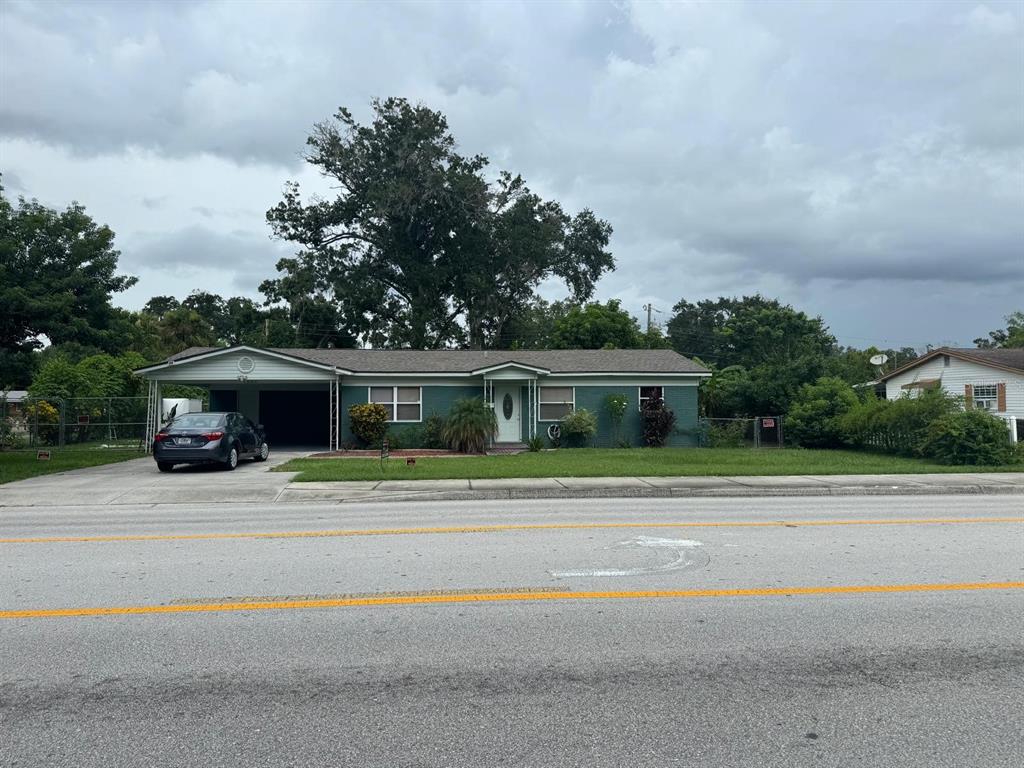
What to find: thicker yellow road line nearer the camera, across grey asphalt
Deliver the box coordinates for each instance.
[0,582,1024,620]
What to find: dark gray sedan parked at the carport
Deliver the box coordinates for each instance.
[153,413,270,472]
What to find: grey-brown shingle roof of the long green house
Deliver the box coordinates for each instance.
[159,347,711,376]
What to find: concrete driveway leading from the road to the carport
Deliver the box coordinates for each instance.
[0,451,308,507]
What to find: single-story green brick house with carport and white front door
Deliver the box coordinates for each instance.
[136,346,711,449]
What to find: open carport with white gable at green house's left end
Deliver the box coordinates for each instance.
[135,347,349,451]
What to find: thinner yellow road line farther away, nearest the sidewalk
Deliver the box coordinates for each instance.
[0,517,1024,544]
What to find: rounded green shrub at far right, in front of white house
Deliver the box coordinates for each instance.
[921,411,1016,466]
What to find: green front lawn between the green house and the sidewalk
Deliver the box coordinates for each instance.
[278,449,1024,482]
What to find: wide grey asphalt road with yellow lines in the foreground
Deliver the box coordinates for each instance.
[0,496,1024,768]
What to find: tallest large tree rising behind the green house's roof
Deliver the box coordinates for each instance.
[261,98,614,348]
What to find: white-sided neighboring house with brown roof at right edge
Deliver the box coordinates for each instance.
[880,347,1024,442]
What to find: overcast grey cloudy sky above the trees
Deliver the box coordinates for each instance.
[0,0,1024,352]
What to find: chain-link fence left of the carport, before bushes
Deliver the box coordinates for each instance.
[0,396,150,451]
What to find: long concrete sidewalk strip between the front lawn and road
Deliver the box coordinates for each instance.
[278,472,1024,503]
